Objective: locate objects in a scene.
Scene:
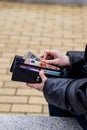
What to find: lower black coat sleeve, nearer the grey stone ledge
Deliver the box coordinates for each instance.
[43,78,87,115]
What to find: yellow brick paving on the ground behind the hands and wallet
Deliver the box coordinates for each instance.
[0,2,87,115]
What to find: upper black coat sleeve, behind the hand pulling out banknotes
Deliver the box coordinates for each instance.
[66,45,87,78]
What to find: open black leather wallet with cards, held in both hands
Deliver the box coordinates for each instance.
[10,55,63,83]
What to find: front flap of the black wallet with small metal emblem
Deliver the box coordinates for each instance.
[12,67,41,83]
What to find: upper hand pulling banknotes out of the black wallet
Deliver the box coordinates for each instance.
[41,50,70,66]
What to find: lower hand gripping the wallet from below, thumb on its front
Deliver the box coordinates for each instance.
[26,70,47,91]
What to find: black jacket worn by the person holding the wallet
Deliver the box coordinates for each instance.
[43,44,87,115]
